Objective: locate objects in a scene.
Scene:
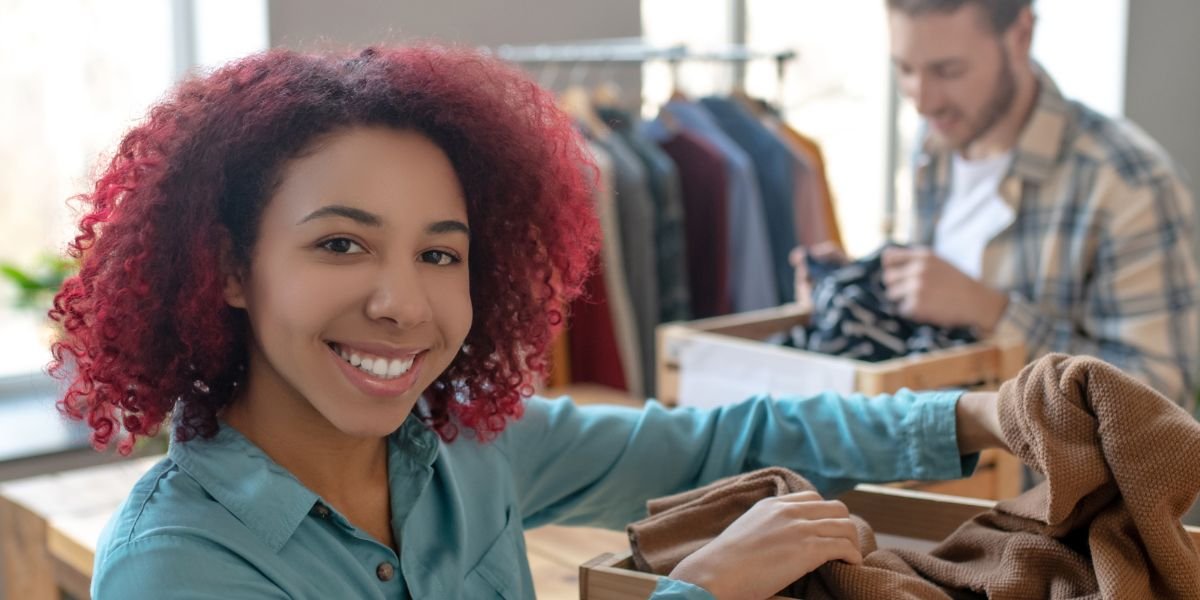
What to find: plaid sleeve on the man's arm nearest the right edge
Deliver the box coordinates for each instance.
[996,176,1200,408]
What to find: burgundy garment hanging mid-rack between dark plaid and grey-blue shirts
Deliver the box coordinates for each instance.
[659,131,733,318]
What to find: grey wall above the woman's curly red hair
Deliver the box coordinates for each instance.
[269,0,642,98]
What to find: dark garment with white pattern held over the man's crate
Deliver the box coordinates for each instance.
[792,250,976,362]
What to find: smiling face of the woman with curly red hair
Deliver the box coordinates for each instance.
[226,127,472,437]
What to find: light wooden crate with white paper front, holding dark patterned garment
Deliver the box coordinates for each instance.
[656,305,1025,499]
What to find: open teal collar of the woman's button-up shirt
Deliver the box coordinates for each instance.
[167,415,440,552]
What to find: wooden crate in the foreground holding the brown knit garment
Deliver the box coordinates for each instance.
[580,485,1200,600]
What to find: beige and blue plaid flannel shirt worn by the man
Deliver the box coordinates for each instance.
[912,70,1200,409]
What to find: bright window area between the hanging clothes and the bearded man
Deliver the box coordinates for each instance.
[745,0,890,256]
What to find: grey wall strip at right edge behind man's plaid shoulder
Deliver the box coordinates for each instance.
[1124,0,1200,202]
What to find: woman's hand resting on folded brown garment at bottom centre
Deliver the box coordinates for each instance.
[671,492,863,600]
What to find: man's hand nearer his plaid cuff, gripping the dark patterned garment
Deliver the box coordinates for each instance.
[883,247,1008,335]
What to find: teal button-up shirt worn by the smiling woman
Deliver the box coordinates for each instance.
[92,391,974,600]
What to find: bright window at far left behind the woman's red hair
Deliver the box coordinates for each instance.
[0,0,266,377]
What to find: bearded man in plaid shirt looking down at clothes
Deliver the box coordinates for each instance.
[883,0,1200,408]
